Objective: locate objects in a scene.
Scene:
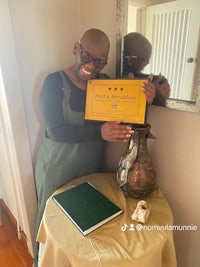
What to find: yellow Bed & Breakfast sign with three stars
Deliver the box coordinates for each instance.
[85,79,146,124]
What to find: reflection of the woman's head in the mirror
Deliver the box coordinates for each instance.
[123,32,152,75]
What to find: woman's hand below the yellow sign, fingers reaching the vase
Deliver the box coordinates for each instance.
[101,121,134,143]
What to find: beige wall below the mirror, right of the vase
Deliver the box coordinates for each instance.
[149,106,200,267]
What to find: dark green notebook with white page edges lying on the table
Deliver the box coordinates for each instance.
[53,182,122,235]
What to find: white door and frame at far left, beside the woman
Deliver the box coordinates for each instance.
[0,0,37,255]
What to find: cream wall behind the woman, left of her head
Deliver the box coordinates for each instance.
[10,0,80,164]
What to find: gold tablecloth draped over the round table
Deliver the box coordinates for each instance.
[37,173,177,267]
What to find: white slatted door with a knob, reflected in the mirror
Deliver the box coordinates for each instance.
[146,0,200,101]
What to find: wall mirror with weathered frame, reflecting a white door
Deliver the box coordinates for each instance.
[116,0,200,113]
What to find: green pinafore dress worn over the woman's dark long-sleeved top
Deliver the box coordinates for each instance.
[35,71,103,241]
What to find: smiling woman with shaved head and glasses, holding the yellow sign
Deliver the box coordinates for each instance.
[35,29,133,266]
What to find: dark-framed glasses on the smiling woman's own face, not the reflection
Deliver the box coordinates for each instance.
[79,41,107,69]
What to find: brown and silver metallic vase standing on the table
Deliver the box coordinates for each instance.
[117,124,156,199]
